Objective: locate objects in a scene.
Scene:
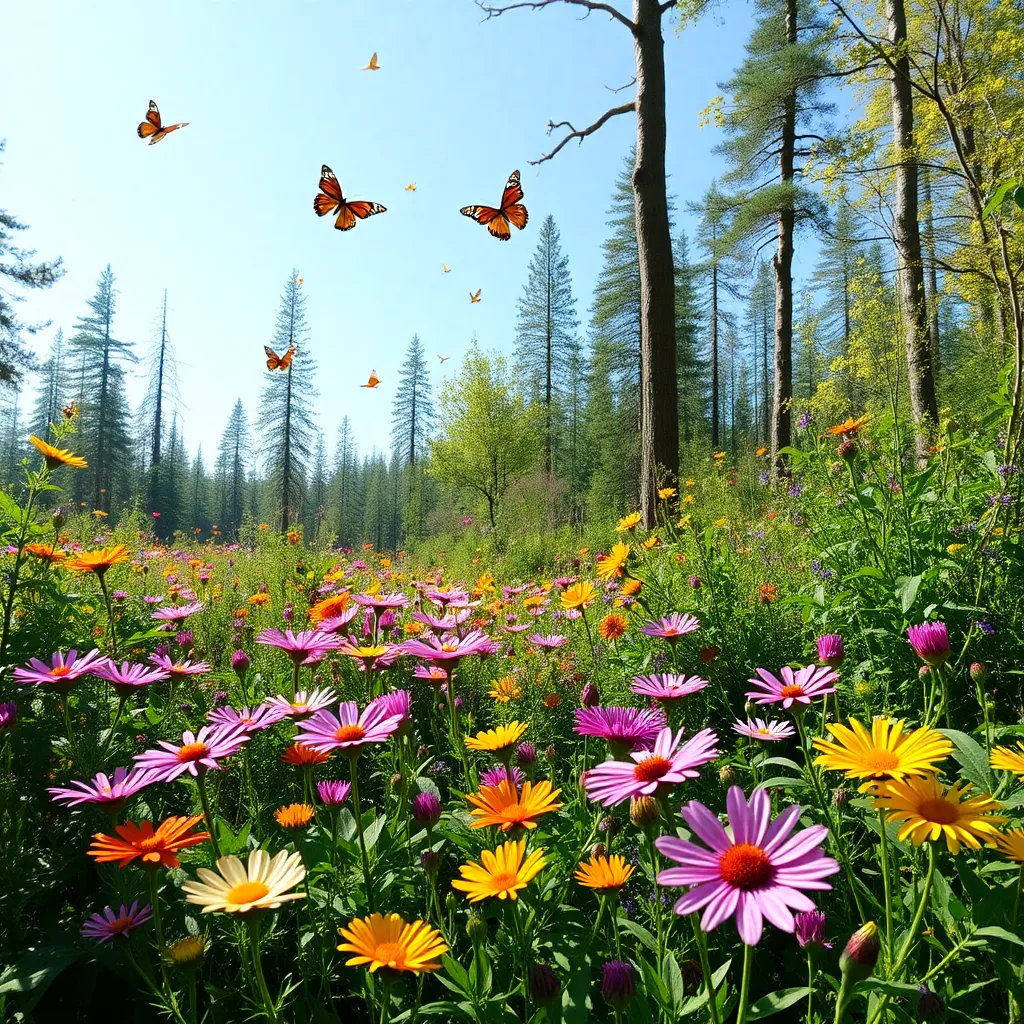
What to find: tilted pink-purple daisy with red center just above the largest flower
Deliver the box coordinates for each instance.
[584,726,718,807]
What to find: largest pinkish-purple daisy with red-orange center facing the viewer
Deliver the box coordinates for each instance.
[654,785,839,946]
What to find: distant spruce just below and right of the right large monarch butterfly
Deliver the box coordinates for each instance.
[515,214,581,473]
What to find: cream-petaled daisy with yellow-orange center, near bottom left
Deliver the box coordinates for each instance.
[181,850,306,916]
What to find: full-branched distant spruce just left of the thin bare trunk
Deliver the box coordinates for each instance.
[71,266,135,512]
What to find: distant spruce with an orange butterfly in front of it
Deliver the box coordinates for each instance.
[259,269,316,532]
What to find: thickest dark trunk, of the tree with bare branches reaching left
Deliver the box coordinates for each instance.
[633,0,679,526]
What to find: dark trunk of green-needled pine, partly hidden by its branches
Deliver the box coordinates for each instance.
[769,0,797,465]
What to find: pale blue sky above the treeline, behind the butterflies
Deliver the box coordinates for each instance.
[0,0,770,457]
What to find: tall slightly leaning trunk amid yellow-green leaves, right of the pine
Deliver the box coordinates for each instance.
[886,0,939,444]
